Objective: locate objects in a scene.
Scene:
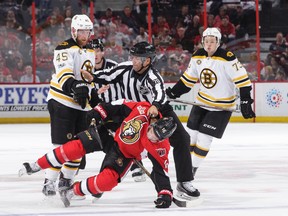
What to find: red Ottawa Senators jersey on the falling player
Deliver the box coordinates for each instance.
[94,99,170,172]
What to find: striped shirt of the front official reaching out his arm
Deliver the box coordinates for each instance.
[94,61,167,108]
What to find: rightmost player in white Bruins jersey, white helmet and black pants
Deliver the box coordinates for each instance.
[166,28,255,174]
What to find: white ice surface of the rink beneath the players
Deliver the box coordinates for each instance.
[0,123,288,216]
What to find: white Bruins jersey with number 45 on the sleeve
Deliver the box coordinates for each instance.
[47,38,95,111]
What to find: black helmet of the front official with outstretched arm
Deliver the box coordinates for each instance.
[130,41,156,60]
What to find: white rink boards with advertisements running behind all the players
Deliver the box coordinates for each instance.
[0,83,288,123]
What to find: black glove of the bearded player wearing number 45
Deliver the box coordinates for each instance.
[71,80,89,109]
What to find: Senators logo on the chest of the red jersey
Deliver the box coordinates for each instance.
[120,116,148,144]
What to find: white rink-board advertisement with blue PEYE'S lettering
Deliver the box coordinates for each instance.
[0,84,49,122]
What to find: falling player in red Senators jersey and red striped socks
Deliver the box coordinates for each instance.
[19,99,177,208]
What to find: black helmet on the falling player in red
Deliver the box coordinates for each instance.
[151,117,177,140]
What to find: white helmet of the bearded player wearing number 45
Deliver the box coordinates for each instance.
[71,14,94,41]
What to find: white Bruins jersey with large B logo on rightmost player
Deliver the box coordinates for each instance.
[180,48,251,108]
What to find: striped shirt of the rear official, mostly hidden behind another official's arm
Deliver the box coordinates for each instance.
[94,58,123,103]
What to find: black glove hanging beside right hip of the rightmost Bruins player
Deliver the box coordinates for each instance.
[240,86,256,119]
